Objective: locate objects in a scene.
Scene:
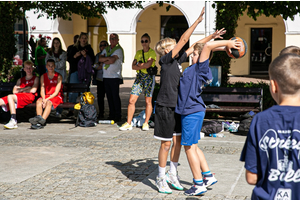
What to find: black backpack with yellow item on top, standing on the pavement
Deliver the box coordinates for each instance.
[74,92,97,127]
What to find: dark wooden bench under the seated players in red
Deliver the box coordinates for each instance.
[0,83,89,108]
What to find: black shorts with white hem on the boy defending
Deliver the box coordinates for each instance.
[154,104,181,141]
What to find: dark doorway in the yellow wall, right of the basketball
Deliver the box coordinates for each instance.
[250,28,272,74]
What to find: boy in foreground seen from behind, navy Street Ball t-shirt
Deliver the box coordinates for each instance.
[240,54,300,200]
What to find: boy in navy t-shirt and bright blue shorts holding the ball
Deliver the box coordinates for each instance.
[175,40,241,196]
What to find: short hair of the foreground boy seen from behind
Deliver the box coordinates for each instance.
[269,53,300,95]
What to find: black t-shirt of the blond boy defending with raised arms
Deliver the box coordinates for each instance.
[156,51,187,107]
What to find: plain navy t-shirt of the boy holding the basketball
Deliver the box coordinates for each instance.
[175,59,212,115]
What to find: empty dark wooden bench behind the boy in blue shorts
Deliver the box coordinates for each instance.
[201,87,263,113]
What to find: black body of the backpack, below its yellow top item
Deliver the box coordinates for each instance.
[75,104,97,127]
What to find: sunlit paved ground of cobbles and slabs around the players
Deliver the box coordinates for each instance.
[0,79,253,200]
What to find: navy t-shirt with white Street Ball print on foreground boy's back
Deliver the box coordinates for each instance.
[240,105,300,200]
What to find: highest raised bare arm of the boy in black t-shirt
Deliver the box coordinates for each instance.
[172,7,205,58]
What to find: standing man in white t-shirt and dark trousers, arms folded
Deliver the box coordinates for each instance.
[99,33,124,122]
